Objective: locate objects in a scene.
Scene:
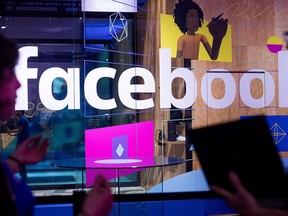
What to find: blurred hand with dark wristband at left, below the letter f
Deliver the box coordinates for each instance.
[12,136,49,165]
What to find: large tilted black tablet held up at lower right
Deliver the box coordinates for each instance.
[187,116,288,208]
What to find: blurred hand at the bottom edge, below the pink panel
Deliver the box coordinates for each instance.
[80,175,113,216]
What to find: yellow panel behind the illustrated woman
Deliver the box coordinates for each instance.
[160,14,232,62]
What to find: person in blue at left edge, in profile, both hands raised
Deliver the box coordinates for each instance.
[0,32,113,216]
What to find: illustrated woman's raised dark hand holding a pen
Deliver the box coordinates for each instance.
[208,18,228,41]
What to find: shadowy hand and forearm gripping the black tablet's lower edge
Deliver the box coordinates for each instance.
[211,172,288,216]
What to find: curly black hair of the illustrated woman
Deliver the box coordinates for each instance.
[173,0,204,34]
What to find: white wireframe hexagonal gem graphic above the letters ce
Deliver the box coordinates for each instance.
[109,12,128,42]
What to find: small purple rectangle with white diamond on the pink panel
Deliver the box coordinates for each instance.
[112,135,128,159]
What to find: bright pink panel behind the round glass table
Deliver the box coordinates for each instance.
[85,121,154,186]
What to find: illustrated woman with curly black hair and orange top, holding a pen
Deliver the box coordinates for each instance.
[173,0,228,60]
